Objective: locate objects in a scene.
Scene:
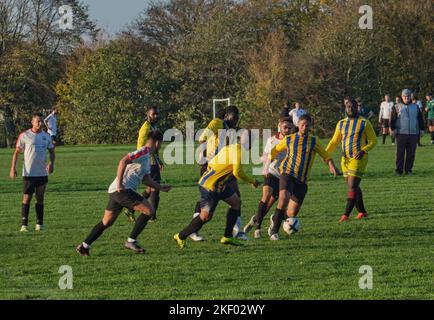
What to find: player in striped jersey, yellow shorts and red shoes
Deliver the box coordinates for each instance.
[326,100,377,223]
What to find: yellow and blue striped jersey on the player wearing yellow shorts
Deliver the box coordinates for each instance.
[326,117,377,159]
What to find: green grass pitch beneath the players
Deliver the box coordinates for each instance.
[0,136,434,299]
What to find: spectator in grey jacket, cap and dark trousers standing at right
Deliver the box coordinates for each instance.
[390,89,424,176]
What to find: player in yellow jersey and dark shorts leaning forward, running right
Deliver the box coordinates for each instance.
[173,130,259,249]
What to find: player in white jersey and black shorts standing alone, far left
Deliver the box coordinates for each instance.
[9,113,55,232]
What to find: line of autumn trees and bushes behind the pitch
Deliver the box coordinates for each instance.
[0,0,434,144]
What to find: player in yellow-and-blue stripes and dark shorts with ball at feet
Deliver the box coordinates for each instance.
[268,114,338,241]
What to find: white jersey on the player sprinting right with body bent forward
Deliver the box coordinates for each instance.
[108,147,151,193]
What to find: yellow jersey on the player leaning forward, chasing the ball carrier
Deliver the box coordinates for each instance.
[199,143,255,192]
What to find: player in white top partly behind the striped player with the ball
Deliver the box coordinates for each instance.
[243,118,292,239]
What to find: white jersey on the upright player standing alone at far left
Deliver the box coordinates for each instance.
[16,129,54,177]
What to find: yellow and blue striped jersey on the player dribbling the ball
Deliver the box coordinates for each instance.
[269,133,330,183]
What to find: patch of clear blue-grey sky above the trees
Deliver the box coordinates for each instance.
[82,0,150,35]
